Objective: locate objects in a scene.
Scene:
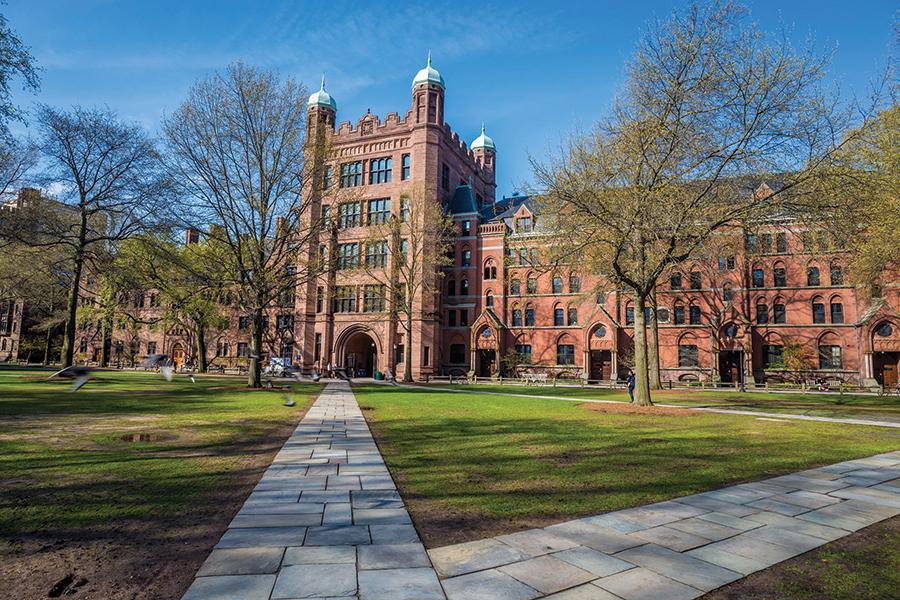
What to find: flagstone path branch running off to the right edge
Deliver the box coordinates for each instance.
[429,451,900,600]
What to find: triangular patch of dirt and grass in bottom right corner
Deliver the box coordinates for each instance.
[703,517,900,600]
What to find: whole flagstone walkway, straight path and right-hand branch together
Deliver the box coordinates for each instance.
[183,382,900,600]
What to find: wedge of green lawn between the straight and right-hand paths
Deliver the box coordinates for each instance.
[354,385,900,546]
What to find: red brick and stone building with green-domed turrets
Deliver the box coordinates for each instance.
[61,58,900,384]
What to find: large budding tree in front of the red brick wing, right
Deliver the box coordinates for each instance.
[535,2,868,404]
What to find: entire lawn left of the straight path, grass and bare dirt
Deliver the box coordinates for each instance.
[0,370,321,598]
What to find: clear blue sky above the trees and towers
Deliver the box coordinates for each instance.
[7,0,897,195]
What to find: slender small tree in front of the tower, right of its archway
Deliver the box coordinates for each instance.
[359,186,456,381]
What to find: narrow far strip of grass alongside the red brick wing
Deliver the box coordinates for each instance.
[420,384,900,423]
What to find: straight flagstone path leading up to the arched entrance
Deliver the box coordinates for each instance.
[183,382,445,600]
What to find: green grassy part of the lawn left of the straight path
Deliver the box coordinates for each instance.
[0,370,320,541]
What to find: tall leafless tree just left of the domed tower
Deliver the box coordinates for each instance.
[163,63,318,387]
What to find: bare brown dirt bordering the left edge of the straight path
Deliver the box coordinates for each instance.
[0,411,305,600]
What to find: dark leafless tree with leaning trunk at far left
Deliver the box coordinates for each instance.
[3,106,168,366]
